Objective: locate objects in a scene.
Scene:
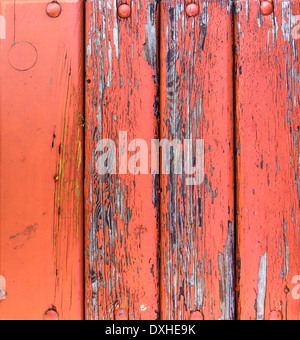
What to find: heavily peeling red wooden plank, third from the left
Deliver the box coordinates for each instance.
[160,0,235,320]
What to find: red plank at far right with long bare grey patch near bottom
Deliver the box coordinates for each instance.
[235,0,300,320]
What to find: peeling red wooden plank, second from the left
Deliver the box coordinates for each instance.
[85,0,158,319]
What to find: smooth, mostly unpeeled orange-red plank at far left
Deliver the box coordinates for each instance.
[0,0,83,320]
